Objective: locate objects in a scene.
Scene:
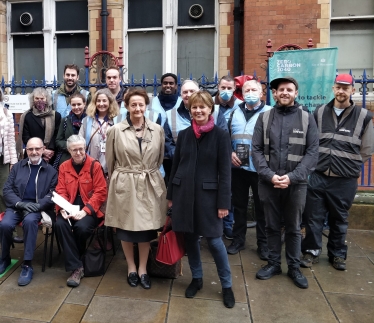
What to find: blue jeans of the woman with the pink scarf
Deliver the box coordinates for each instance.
[185,233,232,288]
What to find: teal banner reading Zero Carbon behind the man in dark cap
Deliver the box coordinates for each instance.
[269,47,338,111]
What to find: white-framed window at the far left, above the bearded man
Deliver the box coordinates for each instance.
[7,0,89,82]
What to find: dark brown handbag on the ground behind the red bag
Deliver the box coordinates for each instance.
[147,240,183,279]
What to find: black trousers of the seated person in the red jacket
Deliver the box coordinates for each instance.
[55,213,98,271]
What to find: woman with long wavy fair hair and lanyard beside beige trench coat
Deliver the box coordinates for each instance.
[79,89,119,173]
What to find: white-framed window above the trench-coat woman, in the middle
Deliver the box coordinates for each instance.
[124,0,218,80]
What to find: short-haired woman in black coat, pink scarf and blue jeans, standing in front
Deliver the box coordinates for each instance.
[167,91,235,308]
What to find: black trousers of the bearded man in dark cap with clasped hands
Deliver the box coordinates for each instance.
[258,181,307,268]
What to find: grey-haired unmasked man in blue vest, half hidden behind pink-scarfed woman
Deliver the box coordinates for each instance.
[164,80,228,158]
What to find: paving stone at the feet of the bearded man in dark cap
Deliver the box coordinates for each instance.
[244,272,336,323]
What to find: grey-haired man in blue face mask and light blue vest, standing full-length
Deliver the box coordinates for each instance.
[227,80,271,260]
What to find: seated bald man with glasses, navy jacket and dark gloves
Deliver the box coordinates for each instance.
[0,137,57,286]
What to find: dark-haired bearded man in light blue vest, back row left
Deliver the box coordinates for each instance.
[52,64,91,118]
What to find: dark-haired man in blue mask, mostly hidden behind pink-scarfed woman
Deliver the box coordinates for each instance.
[213,75,243,239]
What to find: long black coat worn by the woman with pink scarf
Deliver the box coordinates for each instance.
[167,126,231,237]
